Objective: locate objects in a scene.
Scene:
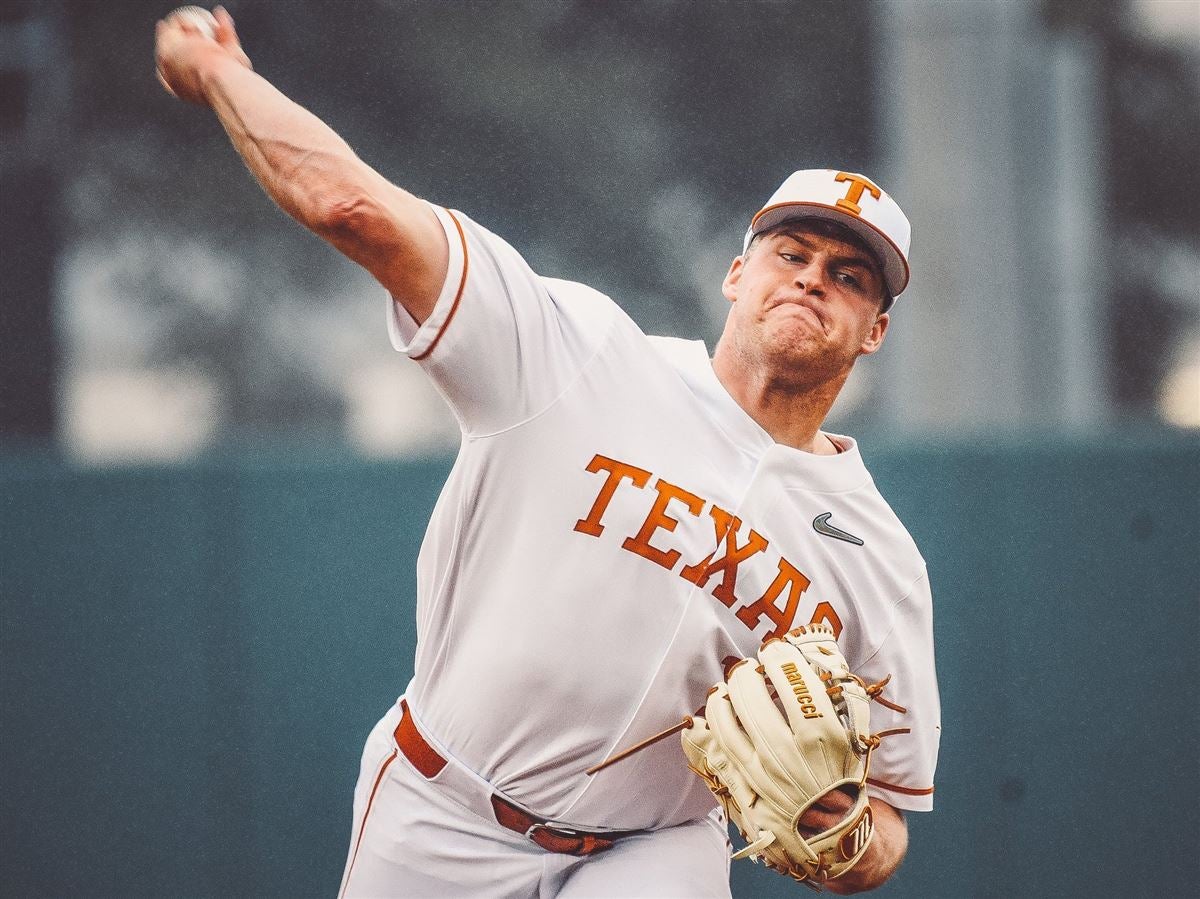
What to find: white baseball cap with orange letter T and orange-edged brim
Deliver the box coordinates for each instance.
[742,168,912,305]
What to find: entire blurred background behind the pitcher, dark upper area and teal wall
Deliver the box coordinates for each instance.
[0,0,1200,897]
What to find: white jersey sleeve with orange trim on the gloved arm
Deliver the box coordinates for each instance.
[856,575,942,811]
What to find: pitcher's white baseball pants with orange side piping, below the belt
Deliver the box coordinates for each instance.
[340,703,731,899]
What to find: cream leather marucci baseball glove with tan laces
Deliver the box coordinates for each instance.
[682,624,878,887]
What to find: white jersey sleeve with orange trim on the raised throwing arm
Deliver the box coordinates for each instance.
[389,206,618,436]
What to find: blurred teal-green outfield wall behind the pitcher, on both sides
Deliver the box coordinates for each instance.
[0,434,1200,899]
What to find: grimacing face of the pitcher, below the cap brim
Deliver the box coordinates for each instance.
[722,224,888,382]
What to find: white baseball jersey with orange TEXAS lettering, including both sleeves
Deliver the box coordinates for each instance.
[390,208,940,828]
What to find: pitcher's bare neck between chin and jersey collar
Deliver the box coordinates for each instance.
[713,352,850,456]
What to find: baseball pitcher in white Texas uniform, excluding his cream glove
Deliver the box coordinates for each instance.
[157,8,940,898]
